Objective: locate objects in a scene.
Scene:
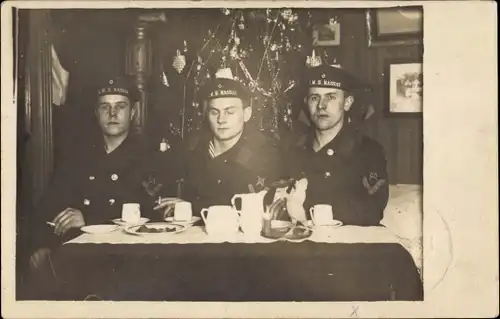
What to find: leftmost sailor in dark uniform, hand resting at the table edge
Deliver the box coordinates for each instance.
[31,78,152,266]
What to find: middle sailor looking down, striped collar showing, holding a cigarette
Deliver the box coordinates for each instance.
[154,78,281,214]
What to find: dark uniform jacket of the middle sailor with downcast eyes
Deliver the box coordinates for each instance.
[182,130,283,214]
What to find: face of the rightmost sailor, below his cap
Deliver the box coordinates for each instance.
[306,87,354,131]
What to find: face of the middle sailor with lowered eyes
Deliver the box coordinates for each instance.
[207,97,252,141]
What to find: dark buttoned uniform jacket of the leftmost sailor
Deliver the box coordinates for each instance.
[28,135,152,251]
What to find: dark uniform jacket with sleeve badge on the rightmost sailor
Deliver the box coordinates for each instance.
[285,123,389,226]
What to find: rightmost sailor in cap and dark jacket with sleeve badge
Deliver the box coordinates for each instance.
[285,65,388,226]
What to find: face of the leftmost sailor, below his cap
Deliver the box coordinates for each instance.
[96,94,134,136]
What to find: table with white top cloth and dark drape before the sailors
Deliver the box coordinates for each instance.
[24,220,423,302]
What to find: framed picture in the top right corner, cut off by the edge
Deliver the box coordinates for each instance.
[365,6,423,47]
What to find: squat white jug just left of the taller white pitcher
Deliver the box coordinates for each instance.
[201,205,239,235]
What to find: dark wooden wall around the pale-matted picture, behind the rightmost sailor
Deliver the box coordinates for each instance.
[341,10,423,184]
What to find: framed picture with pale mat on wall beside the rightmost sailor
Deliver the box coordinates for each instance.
[385,60,423,116]
